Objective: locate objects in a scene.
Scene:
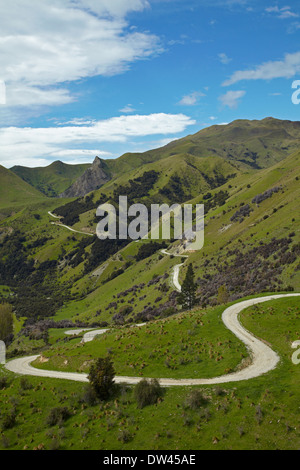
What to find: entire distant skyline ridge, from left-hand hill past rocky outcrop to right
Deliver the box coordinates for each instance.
[20,118,300,197]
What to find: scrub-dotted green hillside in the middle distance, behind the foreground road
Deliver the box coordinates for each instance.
[1,141,300,332]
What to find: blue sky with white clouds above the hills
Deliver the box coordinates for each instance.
[0,0,300,168]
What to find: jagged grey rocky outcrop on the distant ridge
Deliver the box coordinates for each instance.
[60,157,110,197]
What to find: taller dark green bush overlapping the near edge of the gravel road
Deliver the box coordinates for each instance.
[88,357,115,400]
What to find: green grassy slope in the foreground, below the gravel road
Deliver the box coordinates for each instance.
[0,299,300,450]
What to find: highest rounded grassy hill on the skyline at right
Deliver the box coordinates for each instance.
[105,118,300,176]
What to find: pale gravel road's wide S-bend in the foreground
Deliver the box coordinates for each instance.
[5,294,300,387]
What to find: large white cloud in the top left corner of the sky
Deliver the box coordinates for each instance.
[0,0,162,106]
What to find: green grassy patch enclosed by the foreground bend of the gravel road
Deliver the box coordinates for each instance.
[31,307,248,378]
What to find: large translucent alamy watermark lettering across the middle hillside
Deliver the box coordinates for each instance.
[96,196,204,251]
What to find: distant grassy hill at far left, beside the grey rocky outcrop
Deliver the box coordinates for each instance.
[11,161,91,197]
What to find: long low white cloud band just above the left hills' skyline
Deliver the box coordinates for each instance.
[0,114,195,167]
